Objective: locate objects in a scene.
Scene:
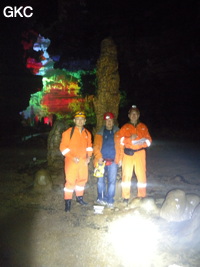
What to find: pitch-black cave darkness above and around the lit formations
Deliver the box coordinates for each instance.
[0,0,200,142]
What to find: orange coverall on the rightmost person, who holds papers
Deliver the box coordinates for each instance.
[119,122,152,199]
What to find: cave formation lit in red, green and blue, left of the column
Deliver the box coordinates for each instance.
[20,32,95,126]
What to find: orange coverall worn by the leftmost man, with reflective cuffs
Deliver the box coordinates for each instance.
[60,127,93,200]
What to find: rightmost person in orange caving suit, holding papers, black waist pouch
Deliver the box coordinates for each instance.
[119,105,152,205]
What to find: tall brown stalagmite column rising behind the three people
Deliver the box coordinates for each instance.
[94,38,120,130]
